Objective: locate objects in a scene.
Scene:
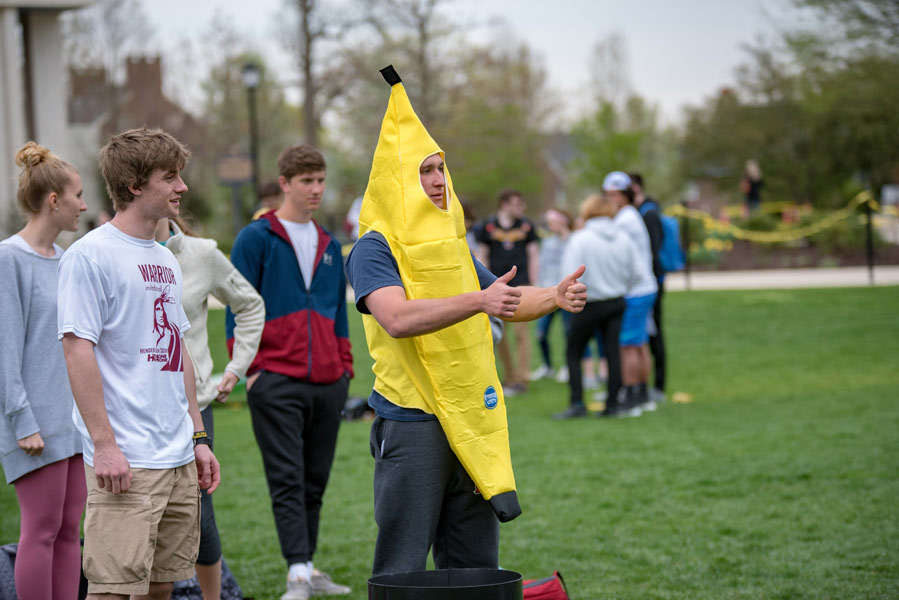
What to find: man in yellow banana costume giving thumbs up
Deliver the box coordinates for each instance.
[346,67,586,575]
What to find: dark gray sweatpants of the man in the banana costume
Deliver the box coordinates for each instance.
[370,417,499,576]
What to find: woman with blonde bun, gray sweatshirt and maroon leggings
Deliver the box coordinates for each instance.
[0,142,87,600]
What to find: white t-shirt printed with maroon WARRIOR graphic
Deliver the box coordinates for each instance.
[57,223,194,469]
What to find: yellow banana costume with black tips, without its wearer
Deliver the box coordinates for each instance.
[359,66,521,522]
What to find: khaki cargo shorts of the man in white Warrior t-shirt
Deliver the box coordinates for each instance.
[84,463,200,594]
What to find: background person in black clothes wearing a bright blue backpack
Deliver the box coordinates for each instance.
[630,173,665,401]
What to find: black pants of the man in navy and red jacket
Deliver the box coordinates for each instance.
[247,371,349,565]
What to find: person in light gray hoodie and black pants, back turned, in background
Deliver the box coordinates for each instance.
[554,195,640,419]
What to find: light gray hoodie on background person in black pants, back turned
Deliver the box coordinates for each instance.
[562,217,640,302]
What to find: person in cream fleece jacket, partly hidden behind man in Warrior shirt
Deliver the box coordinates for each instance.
[156,217,265,600]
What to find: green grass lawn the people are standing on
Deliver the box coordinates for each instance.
[0,288,899,600]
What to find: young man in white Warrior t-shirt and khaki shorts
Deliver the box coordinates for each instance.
[58,128,220,599]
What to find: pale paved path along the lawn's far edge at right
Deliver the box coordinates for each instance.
[665,265,899,292]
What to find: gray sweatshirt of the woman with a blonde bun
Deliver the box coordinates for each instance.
[0,235,81,483]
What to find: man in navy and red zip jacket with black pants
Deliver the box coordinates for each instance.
[226,145,353,599]
